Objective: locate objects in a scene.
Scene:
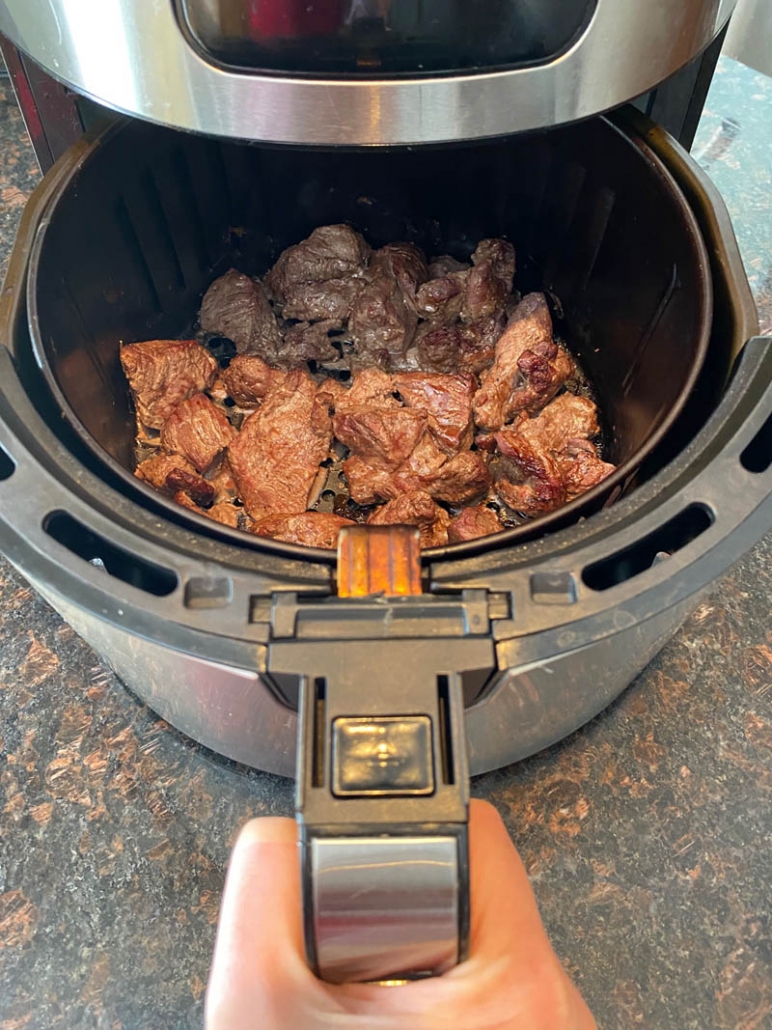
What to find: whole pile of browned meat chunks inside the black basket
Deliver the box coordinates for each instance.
[120,226,613,548]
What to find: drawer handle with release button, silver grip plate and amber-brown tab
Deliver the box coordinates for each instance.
[297,527,468,982]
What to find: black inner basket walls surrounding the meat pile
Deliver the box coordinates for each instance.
[28,113,712,559]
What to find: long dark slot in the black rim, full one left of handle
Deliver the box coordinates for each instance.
[43,512,178,597]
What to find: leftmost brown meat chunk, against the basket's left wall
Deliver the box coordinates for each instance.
[120,340,217,430]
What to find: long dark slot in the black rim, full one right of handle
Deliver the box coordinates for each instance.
[582,505,713,590]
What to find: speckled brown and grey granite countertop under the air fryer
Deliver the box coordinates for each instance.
[0,60,772,1030]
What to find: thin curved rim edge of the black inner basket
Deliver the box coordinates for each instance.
[27,117,712,564]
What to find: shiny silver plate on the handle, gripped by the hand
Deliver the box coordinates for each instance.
[311,836,458,983]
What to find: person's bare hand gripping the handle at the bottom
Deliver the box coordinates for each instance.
[206,801,595,1030]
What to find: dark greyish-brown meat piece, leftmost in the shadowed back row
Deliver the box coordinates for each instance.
[199,268,281,362]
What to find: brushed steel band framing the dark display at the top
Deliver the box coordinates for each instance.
[0,0,733,145]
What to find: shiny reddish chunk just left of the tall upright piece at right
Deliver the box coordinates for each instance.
[394,372,477,454]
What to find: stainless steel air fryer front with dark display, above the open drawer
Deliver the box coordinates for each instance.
[0,0,736,145]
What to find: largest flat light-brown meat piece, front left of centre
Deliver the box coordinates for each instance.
[227,370,332,518]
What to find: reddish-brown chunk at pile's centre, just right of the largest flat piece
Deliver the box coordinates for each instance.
[332,408,427,470]
